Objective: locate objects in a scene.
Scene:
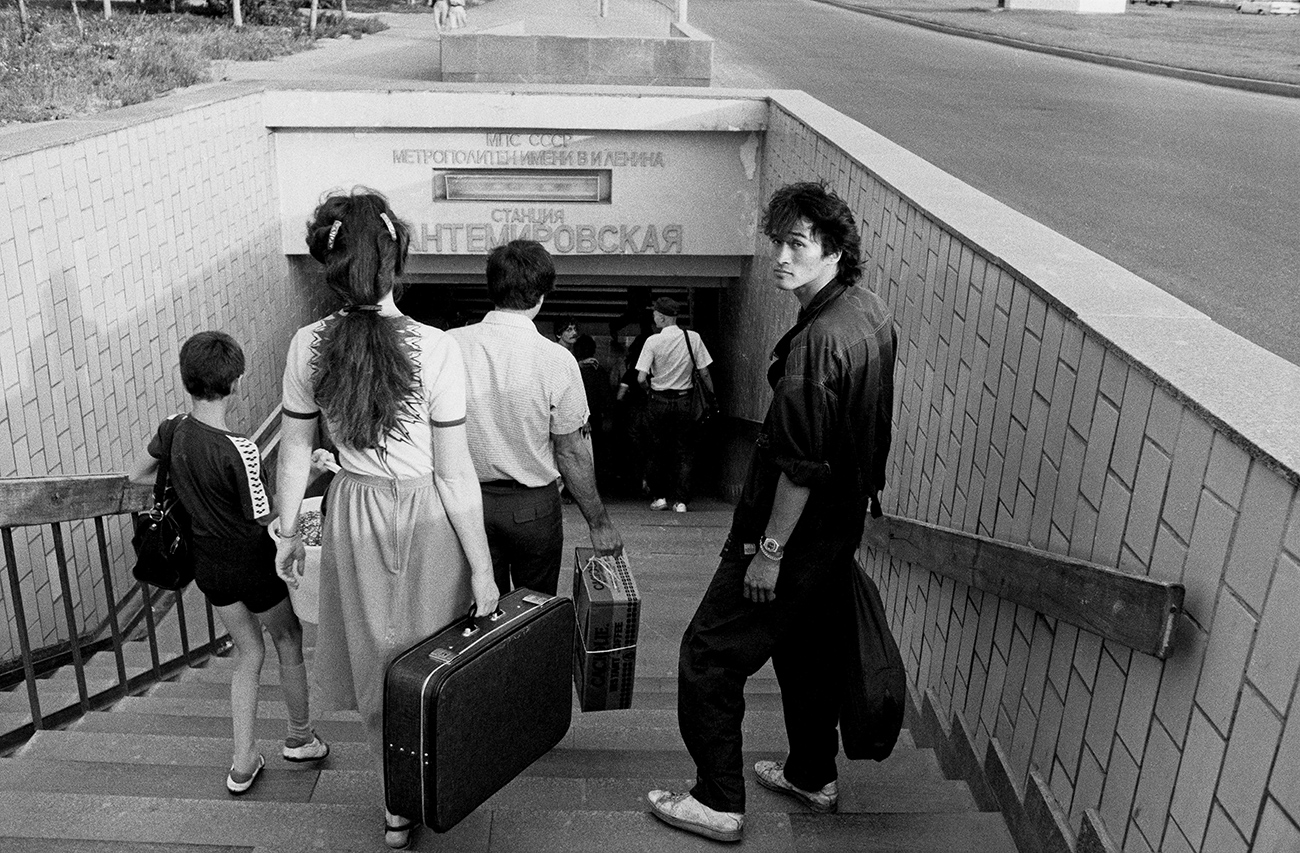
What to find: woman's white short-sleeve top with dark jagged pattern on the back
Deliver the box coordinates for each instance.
[283,313,465,480]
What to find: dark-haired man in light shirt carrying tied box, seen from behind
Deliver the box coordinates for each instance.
[451,241,623,596]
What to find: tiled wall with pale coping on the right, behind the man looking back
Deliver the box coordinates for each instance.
[724,94,1300,853]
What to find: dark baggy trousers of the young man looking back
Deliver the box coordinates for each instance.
[677,542,857,811]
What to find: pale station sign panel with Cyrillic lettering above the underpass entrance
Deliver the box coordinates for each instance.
[274,129,761,256]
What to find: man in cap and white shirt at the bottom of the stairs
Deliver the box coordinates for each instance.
[637,296,714,512]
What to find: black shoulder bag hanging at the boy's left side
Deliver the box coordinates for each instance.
[131,424,194,589]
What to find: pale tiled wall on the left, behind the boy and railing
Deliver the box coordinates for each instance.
[0,86,330,662]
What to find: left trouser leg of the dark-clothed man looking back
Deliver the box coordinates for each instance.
[677,557,780,811]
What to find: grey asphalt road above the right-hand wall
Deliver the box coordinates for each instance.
[690,0,1300,364]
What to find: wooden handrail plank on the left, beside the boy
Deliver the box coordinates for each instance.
[0,473,153,527]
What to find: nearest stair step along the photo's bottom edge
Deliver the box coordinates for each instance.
[0,792,1015,853]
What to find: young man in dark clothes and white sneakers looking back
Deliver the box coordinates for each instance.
[649,183,897,841]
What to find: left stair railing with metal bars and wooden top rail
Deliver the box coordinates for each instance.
[0,407,280,753]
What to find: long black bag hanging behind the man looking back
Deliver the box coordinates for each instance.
[840,560,907,761]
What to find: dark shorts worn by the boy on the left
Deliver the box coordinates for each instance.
[194,534,289,612]
